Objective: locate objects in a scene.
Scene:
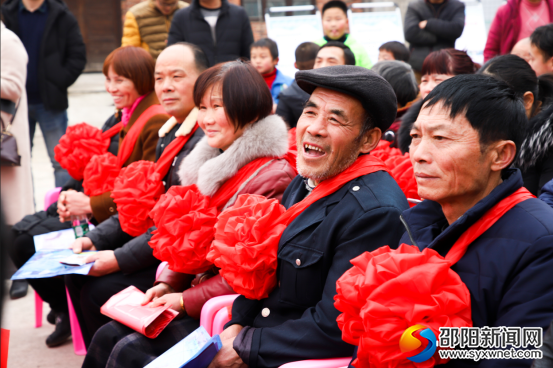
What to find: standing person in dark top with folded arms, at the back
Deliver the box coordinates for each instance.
[403,0,465,73]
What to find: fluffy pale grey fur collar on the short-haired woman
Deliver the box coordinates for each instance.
[178,115,288,196]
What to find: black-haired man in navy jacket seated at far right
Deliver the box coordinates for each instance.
[400,75,553,368]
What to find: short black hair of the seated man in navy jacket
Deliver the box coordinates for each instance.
[423,74,528,152]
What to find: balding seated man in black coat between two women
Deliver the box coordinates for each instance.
[61,44,207,349]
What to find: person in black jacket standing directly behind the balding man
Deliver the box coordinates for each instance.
[167,0,253,66]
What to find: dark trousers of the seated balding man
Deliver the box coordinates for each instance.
[65,265,157,349]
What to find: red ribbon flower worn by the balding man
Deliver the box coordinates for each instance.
[111,160,165,236]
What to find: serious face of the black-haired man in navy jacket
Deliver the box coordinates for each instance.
[409,103,492,204]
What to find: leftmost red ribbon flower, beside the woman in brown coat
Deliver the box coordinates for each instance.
[54,123,109,180]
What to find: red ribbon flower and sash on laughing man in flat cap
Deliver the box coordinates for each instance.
[207,155,388,299]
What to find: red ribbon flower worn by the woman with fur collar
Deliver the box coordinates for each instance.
[149,185,218,274]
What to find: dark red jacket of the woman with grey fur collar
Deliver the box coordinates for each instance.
[156,159,296,319]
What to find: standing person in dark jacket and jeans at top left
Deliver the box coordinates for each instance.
[2,0,86,187]
